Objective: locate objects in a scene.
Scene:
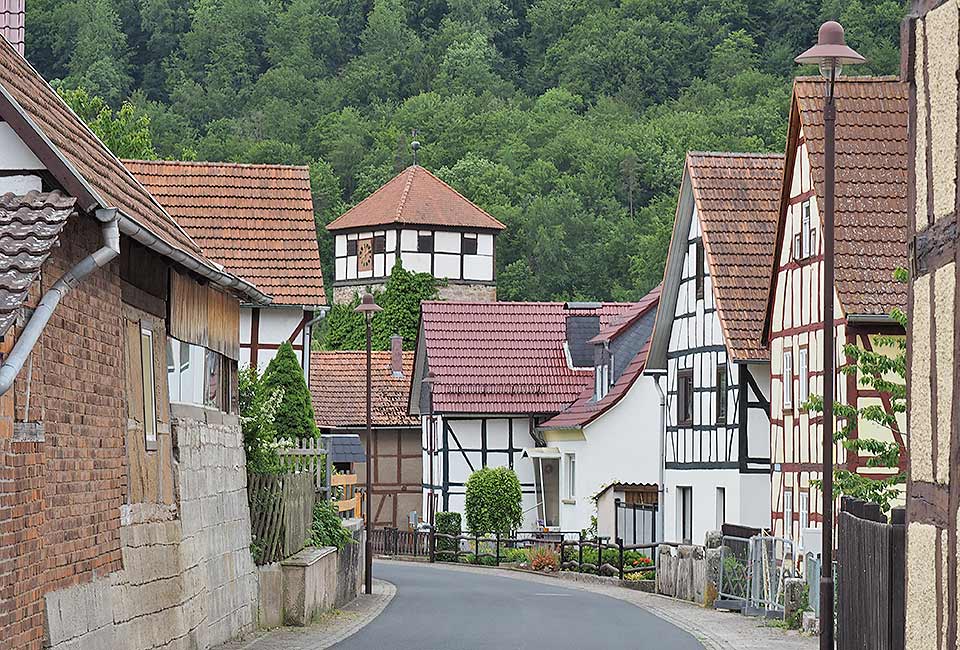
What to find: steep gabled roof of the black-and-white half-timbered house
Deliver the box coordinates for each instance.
[648,152,784,369]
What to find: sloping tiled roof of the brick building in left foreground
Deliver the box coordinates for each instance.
[0,38,270,303]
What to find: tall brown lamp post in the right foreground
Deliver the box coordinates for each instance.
[795,20,865,650]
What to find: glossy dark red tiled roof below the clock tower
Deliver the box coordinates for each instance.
[420,301,631,415]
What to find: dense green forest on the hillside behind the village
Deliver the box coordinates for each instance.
[27,0,905,300]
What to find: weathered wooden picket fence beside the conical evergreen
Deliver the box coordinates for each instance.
[247,472,316,565]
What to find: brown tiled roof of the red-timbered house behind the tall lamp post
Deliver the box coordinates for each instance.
[781,77,909,315]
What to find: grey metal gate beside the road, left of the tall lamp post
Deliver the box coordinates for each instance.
[717,535,798,616]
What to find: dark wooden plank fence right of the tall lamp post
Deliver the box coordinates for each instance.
[837,497,906,650]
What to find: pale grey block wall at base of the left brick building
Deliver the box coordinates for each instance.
[46,407,257,650]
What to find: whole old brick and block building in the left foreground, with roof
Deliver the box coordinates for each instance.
[0,34,269,650]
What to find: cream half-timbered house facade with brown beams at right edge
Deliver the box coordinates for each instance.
[901,1,960,650]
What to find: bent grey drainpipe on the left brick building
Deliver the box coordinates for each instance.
[0,208,120,395]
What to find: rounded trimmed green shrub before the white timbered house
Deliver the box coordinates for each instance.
[464,467,523,535]
